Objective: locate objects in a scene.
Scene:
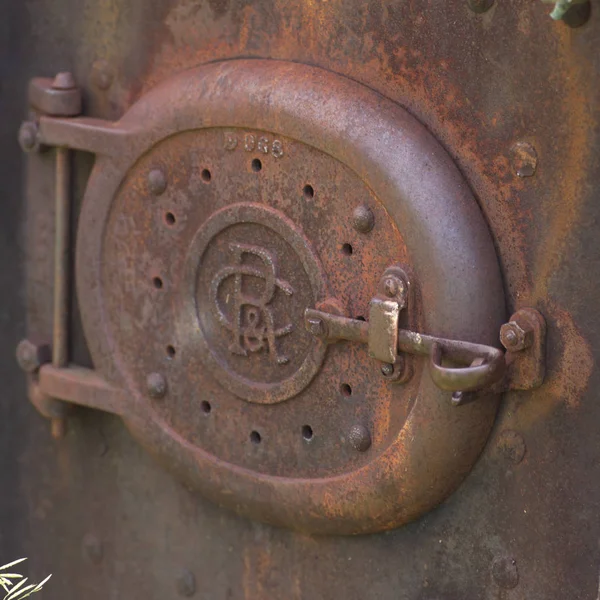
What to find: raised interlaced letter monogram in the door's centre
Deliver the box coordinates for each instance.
[210,243,294,365]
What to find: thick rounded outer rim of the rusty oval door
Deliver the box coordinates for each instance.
[76,60,504,534]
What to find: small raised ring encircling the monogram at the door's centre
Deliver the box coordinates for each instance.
[177,203,327,404]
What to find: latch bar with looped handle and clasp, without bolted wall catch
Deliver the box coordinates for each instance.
[305,266,536,404]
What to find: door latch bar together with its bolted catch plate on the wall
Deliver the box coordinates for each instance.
[305,267,546,398]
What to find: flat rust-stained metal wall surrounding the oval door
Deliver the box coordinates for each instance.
[0,0,600,600]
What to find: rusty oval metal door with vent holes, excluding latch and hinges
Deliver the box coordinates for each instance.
[77,60,503,533]
